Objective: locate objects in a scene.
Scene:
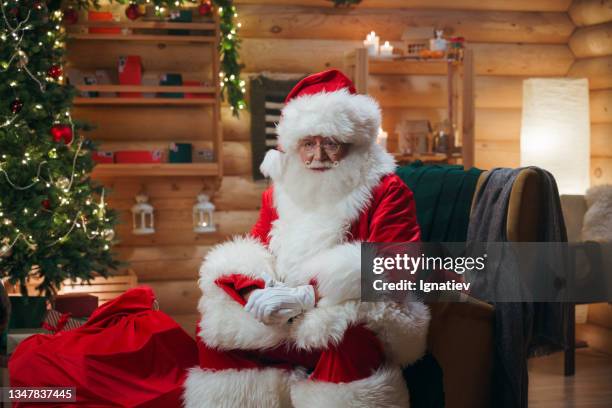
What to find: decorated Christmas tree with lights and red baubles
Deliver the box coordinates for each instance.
[0,0,118,294]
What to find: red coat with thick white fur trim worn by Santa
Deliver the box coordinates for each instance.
[186,166,429,407]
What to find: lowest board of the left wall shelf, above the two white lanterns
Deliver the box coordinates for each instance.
[92,163,219,178]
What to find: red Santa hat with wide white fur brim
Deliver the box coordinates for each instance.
[277,69,381,150]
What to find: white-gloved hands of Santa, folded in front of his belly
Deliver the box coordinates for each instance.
[244,285,315,324]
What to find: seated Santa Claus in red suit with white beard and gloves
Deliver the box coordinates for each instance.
[184,70,429,408]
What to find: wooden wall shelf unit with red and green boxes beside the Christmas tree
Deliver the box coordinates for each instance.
[66,15,223,183]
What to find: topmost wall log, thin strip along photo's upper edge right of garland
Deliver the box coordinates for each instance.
[235,0,572,12]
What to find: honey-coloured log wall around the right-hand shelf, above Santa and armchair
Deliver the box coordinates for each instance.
[237,0,574,168]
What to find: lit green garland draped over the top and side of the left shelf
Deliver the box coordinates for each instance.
[68,0,247,116]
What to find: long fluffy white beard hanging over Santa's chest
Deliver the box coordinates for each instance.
[262,144,395,285]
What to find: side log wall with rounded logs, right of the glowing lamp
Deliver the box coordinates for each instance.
[568,0,612,184]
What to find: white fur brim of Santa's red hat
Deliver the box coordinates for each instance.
[277,89,381,150]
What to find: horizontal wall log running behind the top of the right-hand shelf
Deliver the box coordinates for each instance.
[241,38,574,76]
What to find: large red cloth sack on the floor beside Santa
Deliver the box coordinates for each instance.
[9,287,198,408]
